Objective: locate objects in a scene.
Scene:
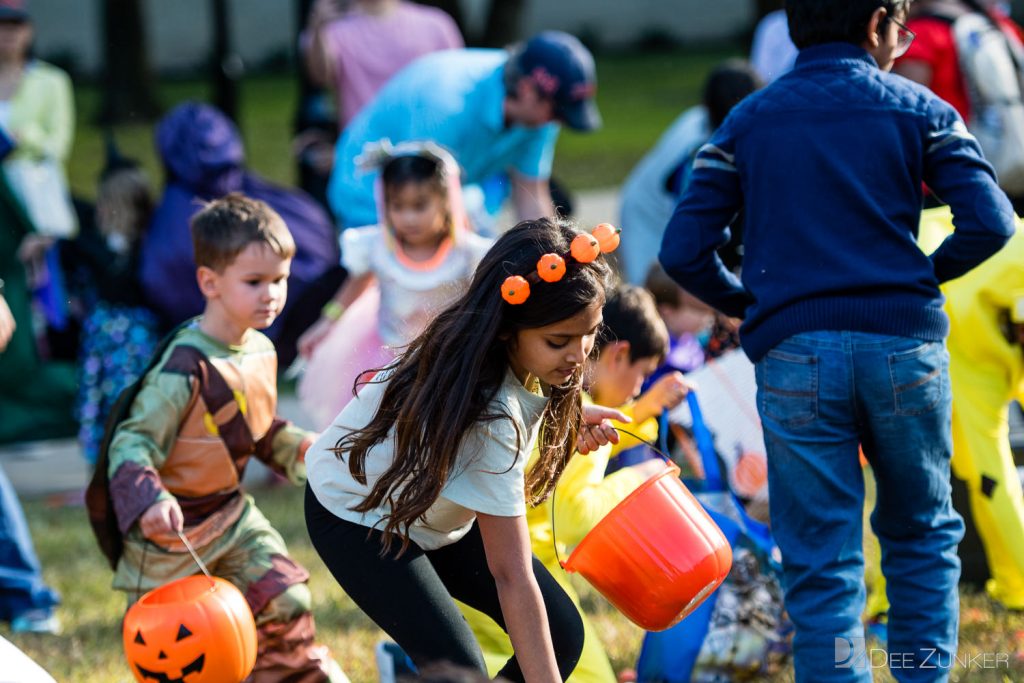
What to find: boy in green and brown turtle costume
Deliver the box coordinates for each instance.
[90,195,346,683]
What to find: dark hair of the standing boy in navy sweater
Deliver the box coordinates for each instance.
[785,0,911,49]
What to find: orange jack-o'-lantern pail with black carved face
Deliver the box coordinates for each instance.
[122,575,256,683]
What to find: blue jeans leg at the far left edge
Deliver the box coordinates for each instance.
[0,462,59,622]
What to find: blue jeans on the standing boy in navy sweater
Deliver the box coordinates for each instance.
[756,332,964,683]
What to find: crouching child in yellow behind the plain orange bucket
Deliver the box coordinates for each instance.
[459,286,688,683]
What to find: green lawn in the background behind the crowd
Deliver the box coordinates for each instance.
[69,49,738,198]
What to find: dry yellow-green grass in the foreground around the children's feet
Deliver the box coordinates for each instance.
[6,487,1024,683]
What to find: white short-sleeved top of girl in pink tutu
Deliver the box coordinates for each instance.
[341,225,492,346]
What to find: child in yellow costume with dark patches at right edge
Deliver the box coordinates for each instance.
[868,208,1024,613]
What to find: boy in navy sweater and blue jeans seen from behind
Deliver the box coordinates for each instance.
[660,0,1014,682]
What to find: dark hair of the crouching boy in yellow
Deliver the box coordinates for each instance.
[598,285,669,362]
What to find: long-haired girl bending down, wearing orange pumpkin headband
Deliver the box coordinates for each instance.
[306,219,625,681]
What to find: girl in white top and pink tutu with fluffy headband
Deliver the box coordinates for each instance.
[298,141,490,429]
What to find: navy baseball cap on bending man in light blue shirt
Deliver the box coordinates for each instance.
[515,31,601,131]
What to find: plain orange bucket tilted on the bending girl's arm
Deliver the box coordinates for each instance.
[562,465,732,631]
